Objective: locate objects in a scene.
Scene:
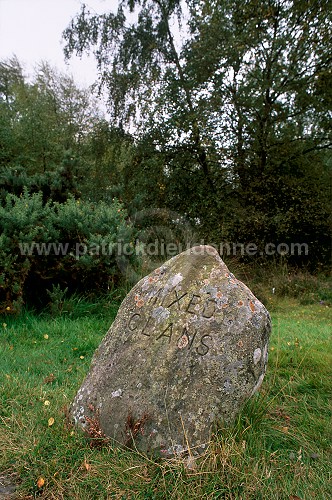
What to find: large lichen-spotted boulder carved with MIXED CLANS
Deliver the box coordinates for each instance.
[71,246,271,456]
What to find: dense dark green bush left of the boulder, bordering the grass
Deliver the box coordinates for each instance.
[0,190,134,312]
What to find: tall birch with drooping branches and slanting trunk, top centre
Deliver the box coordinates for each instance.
[64,0,228,230]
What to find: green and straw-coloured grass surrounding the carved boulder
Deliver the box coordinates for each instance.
[0,298,332,500]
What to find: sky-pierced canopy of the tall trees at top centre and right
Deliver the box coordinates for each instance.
[64,0,331,156]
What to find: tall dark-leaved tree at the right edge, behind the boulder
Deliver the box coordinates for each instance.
[186,0,332,262]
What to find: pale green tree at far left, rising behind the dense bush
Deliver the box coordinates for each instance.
[0,59,101,201]
